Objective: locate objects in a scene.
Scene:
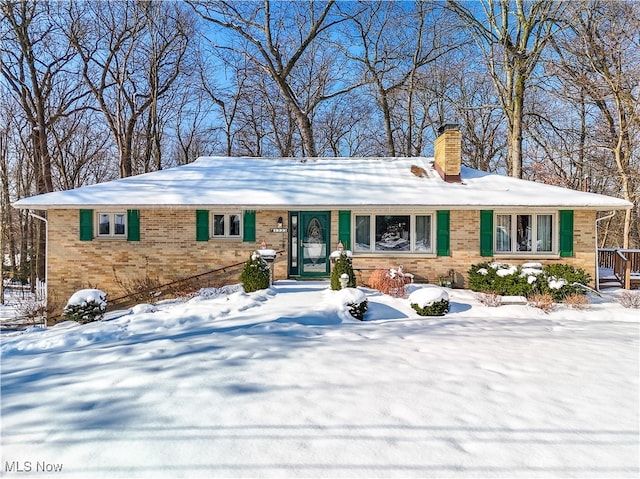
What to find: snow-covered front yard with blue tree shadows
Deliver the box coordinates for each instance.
[0,281,640,478]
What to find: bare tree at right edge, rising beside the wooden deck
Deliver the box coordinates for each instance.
[555,0,640,248]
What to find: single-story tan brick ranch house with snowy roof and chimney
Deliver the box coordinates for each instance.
[14,125,632,312]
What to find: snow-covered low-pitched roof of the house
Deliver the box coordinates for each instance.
[14,157,632,210]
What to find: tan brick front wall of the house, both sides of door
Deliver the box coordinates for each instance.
[47,209,596,316]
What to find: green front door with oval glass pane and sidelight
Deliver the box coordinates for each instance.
[289,211,331,278]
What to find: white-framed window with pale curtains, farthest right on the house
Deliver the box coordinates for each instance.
[495,213,557,254]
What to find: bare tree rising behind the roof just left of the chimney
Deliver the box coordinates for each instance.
[336,1,460,156]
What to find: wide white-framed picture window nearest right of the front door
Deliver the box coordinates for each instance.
[353,214,434,253]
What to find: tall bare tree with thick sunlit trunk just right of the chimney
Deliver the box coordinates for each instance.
[447,0,566,178]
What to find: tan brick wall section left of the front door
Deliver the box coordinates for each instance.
[47,209,287,316]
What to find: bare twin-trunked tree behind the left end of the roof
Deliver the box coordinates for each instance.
[69,0,194,177]
